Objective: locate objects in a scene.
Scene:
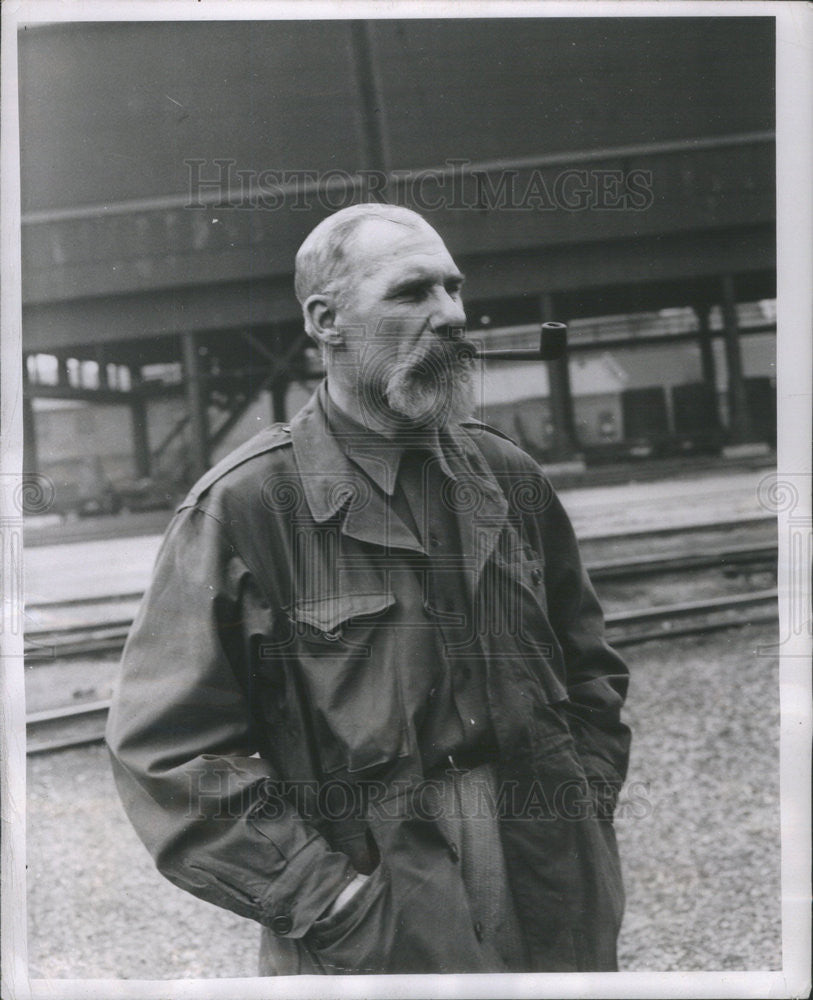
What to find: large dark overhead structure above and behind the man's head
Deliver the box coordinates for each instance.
[15,17,774,351]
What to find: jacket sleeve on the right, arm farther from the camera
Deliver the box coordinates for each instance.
[543,489,630,815]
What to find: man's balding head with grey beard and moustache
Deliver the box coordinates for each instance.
[296,204,472,434]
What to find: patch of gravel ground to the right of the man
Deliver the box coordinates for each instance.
[616,626,781,971]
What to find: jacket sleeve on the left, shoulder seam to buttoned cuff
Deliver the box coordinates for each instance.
[107,508,355,938]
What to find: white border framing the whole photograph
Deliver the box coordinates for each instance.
[0,0,813,1000]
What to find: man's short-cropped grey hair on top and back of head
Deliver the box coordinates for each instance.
[294,202,429,312]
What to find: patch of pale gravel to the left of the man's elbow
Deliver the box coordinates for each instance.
[27,746,258,979]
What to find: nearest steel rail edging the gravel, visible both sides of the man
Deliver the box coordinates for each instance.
[26,589,777,754]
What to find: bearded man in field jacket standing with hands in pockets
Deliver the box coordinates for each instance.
[108,205,629,975]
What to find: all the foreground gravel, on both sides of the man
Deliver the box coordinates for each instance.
[28,626,781,979]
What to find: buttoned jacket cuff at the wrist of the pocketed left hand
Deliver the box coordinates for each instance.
[260,837,357,938]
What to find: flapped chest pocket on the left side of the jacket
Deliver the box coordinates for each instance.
[288,593,409,774]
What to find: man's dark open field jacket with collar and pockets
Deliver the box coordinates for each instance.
[107,388,629,974]
